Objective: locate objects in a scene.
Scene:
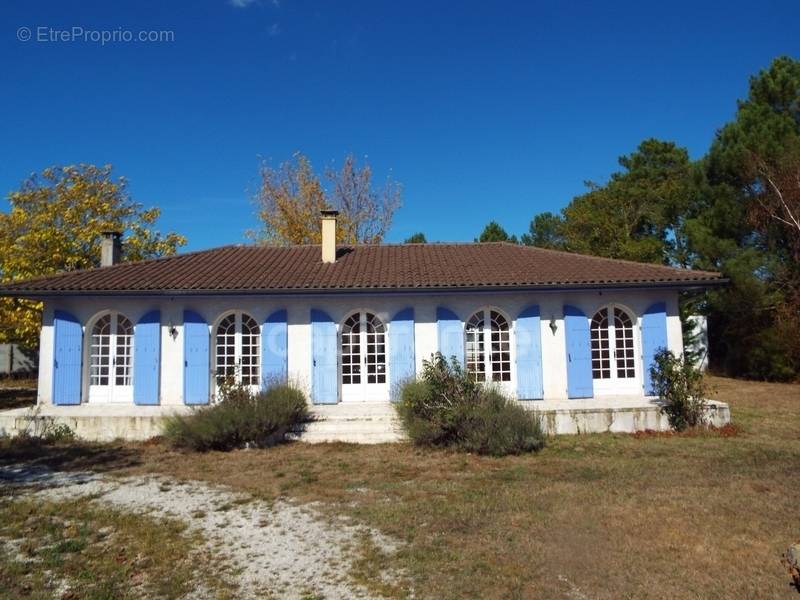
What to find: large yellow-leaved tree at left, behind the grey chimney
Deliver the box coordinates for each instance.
[0,164,186,348]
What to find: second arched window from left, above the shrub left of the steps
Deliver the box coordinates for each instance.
[214,311,261,385]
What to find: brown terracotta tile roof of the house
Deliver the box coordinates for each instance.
[0,243,724,297]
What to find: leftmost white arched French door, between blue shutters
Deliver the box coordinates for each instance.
[89,311,133,402]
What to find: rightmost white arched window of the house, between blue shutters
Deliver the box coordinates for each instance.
[591,305,636,380]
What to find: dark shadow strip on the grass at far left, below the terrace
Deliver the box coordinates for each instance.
[0,439,142,473]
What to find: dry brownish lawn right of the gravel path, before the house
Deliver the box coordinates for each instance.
[1,378,800,598]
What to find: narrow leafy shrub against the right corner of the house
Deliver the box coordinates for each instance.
[650,350,707,431]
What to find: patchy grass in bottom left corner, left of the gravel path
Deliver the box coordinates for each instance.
[0,494,229,598]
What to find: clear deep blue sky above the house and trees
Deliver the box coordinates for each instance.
[0,0,800,249]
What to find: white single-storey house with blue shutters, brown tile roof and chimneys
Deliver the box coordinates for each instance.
[0,212,724,440]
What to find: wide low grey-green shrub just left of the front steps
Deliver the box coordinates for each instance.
[164,383,310,452]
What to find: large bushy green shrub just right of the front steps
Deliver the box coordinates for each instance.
[396,353,545,456]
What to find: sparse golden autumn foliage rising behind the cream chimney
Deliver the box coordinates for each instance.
[250,153,401,245]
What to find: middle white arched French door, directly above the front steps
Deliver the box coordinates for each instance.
[341,312,389,402]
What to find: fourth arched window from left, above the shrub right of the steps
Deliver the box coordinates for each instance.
[465,309,511,381]
